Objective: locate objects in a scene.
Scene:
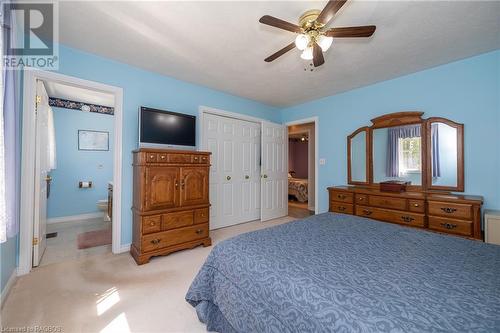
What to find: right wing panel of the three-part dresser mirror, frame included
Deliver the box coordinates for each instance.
[427,118,464,191]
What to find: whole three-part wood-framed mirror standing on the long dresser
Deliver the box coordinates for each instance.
[347,112,464,192]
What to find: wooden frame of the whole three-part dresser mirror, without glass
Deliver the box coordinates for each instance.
[347,111,464,192]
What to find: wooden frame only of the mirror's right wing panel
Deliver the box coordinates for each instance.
[425,117,464,192]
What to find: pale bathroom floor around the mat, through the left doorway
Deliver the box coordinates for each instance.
[40,218,111,266]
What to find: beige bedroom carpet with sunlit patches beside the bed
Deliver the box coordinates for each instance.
[1,217,293,333]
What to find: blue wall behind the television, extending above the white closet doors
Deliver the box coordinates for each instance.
[54,45,280,244]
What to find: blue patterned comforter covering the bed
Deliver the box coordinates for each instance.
[186,213,500,332]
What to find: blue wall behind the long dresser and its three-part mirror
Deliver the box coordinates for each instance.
[281,51,500,211]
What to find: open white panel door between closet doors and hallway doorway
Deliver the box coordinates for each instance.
[261,122,288,221]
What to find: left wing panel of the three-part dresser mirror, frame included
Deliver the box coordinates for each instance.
[347,127,370,184]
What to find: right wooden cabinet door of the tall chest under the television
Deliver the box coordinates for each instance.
[180,167,208,206]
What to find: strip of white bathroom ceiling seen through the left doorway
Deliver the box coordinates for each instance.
[44,81,115,107]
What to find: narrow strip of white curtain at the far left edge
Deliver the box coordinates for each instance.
[0,20,7,243]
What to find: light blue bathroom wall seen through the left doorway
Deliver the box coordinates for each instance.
[48,108,115,218]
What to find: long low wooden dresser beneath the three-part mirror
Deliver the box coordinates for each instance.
[328,186,483,239]
